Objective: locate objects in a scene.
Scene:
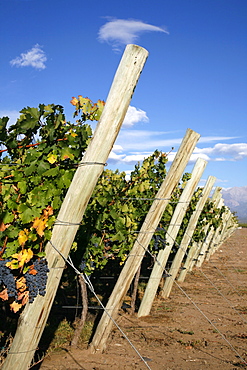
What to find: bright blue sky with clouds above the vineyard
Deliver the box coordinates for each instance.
[0,0,247,188]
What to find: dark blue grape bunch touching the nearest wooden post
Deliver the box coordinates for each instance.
[25,259,49,303]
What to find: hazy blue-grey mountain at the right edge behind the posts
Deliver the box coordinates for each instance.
[222,186,247,223]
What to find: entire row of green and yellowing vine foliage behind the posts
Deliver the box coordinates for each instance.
[0,96,223,312]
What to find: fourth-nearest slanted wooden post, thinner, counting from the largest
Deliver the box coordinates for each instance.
[161,176,216,298]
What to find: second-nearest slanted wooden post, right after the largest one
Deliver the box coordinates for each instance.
[90,129,200,353]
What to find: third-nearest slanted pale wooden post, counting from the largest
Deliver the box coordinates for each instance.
[137,158,207,317]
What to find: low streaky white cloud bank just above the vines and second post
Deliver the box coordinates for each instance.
[109,130,247,165]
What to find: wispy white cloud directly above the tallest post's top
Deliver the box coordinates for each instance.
[98,18,169,51]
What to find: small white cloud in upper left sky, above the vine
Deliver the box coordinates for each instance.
[10,44,47,69]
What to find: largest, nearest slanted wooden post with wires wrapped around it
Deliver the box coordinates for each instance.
[3,45,148,370]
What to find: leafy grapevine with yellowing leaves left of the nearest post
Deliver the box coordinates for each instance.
[0,96,104,312]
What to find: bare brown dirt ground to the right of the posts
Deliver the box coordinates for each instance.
[41,228,247,370]
